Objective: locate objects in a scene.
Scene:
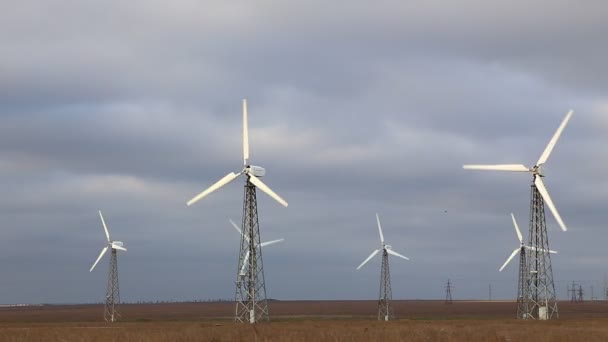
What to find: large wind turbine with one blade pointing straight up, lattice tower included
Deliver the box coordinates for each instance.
[187,100,288,323]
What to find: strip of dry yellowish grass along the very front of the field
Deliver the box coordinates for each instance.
[0,319,608,342]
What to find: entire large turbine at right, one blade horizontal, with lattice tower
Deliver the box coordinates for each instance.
[463,111,573,320]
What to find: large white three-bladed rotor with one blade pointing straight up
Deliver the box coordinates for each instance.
[186,100,288,207]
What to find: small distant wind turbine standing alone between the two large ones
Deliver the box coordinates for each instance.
[357,213,410,321]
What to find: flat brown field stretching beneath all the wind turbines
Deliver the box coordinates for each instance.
[0,301,608,342]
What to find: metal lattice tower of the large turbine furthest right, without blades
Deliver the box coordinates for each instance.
[524,183,559,320]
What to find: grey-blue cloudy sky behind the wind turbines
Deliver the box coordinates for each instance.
[0,0,608,303]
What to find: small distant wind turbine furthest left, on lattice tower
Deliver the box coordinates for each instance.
[89,210,127,322]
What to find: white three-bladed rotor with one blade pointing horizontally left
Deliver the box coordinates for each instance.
[463,110,573,231]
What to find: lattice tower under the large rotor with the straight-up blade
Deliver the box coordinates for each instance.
[234,179,269,323]
